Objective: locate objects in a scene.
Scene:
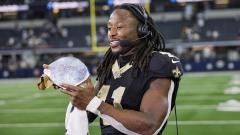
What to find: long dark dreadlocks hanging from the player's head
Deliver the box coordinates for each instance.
[97,4,165,84]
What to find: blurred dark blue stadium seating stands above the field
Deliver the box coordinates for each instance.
[0,2,240,78]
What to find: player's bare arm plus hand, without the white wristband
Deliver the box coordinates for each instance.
[61,79,174,135]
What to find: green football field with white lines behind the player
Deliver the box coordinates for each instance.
[0,72,240,135]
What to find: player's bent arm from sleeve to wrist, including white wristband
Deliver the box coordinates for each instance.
[86,79,174,135]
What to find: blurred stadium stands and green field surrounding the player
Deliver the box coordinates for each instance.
[0,0,240,135]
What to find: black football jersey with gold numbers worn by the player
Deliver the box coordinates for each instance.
[98,52,183,135]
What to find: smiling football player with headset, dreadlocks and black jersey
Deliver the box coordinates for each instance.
[61,4,183,135]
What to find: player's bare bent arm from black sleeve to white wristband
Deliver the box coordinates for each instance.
[98,79,171,135]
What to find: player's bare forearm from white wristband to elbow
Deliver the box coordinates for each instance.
[98,102,158,135]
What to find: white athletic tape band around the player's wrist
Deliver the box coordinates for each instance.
[86,96,102,115]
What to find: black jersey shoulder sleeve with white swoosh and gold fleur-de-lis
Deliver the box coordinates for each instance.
[149,52,183,80]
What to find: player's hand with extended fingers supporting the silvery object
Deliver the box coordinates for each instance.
[60,78,95,110]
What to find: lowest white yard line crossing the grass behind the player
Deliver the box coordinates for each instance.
[0,120,240,128]
